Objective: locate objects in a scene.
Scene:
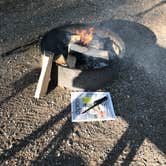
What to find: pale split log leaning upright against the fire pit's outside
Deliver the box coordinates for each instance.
[34,53,54,98]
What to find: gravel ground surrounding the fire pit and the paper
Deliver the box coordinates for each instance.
[0,0,166,166]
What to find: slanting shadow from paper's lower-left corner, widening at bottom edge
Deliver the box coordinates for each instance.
[31,118,86,166]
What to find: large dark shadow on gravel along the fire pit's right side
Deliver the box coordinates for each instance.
[98,20,166,165]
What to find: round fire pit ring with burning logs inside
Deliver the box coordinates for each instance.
[35,25,125,98]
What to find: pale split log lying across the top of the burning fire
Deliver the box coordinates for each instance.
[69,43,109,60]
